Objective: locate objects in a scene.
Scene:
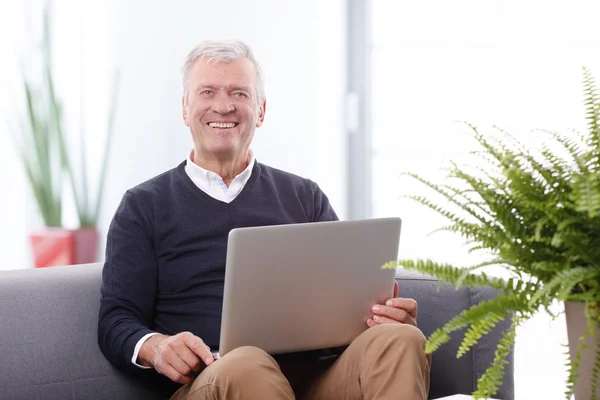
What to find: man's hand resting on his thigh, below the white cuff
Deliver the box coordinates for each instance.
[138,332,215,384]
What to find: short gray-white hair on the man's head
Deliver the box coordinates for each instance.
[181,40,265,105]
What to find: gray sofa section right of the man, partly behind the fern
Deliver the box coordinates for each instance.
[396,269,514,400]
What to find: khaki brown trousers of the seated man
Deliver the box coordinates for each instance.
[171,324,431,400]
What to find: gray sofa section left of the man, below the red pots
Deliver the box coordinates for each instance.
[0,264,159,400]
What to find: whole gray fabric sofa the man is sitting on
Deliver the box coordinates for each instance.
[0,264,514,400]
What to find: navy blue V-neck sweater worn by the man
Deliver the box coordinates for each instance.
[98,162,337,390]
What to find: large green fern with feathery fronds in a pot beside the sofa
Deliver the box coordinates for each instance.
[384,68,600,400]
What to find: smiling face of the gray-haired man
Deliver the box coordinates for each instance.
[183,58,266,161]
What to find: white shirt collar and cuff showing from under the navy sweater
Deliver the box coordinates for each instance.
[131,150,255,369]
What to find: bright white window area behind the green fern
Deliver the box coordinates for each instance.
[370,0,600,400]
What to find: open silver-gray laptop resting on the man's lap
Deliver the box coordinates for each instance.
[216,218,401,357]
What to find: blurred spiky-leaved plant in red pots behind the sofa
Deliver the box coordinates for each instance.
[14,7,117,267]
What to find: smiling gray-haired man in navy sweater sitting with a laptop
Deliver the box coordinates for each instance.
[98,41,431,400]
